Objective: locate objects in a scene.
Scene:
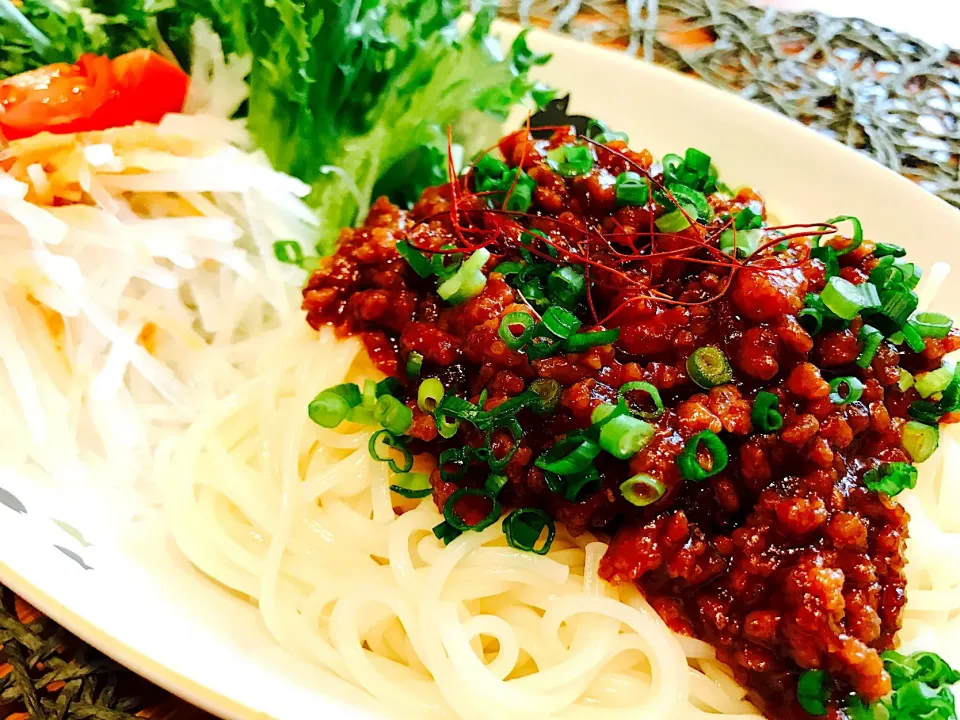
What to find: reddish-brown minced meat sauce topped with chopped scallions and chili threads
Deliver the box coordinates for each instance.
[303,122,960,718]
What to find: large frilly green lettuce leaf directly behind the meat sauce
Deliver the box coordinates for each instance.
[236,0,548,252]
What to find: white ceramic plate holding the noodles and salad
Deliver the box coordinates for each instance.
[0,21,960,719]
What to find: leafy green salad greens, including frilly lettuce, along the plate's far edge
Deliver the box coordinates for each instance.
[0,0,552,252]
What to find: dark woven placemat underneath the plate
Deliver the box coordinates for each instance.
[0,0,960,720]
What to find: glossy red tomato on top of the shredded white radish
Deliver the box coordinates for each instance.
[0,50,189,140]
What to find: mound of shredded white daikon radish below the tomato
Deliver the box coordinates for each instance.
[0,104,316,490]
